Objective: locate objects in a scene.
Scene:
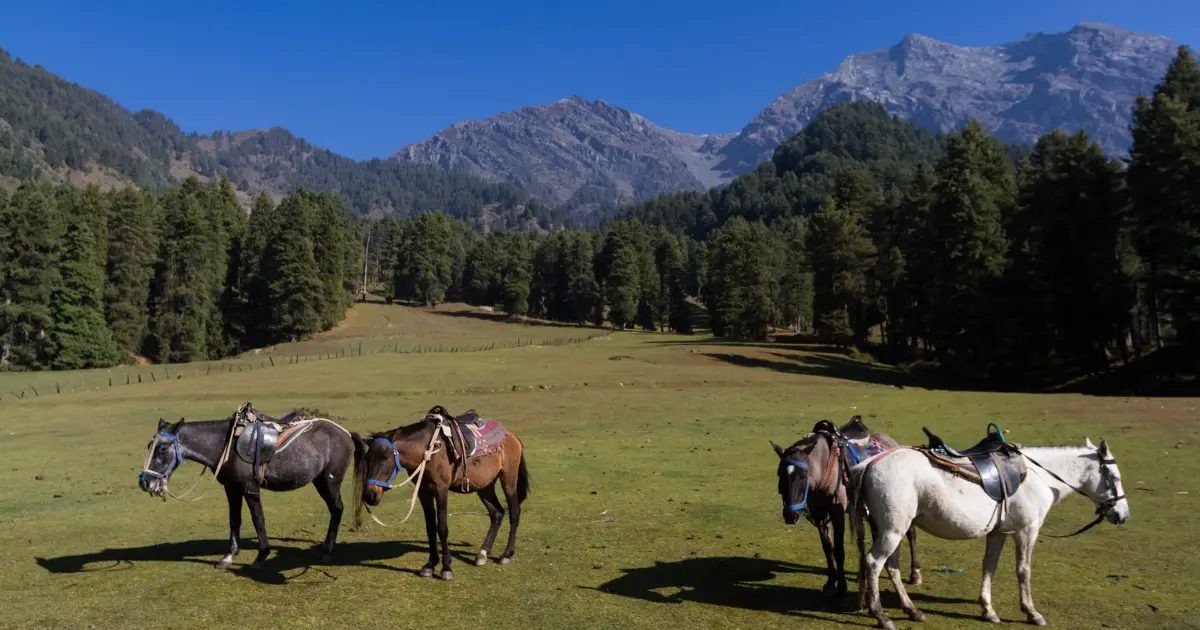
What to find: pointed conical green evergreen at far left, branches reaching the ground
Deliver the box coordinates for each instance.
[47,221,119,370]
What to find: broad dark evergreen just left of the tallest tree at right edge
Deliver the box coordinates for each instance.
[1006,131,1133,373]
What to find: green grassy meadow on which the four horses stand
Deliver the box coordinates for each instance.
[0,305,1200,629]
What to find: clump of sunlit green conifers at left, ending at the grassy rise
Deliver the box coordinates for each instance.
[0,178,361,370]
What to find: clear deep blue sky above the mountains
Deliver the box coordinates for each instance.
[0,0,1200,160]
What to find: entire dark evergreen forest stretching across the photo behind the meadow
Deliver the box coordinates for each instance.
[0,47,1200,385]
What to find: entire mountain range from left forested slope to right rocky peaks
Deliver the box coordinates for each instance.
[0,23,1176,226]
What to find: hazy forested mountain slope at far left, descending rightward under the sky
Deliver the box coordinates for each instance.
[0,49,552,228]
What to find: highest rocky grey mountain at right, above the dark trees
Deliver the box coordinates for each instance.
[719,23,1176,175]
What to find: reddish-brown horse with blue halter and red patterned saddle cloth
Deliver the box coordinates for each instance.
[354,406,529,580]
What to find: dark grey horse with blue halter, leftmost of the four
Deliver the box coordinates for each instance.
[138,418,358,569]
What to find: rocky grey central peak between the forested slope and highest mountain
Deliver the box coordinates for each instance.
[392,96,730,208]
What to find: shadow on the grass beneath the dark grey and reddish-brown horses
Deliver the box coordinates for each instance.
[35,538,465,584]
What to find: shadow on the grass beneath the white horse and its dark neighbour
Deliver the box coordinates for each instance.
[580,557,974,628]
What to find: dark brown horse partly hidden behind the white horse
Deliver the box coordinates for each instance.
[770,415,922,596]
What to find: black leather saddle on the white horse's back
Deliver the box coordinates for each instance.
[922,424,1027,500]
